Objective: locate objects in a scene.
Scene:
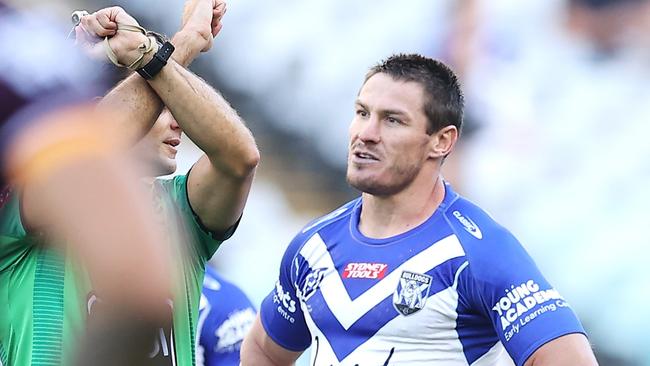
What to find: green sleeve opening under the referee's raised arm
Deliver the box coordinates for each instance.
[162,174,239,261]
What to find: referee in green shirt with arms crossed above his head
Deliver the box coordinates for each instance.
[0,0,259,365]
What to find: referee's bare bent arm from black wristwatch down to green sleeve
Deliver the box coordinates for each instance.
[149,57,259,231]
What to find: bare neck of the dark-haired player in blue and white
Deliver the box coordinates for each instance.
[359,176,445,239]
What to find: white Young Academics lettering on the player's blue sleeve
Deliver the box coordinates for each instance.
[492,280,569,341]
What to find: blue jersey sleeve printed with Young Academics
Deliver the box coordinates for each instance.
[464,232,585,365]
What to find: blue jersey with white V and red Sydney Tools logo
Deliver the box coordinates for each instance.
[261,185,584,366]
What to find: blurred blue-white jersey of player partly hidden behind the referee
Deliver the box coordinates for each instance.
[196,266,257,366]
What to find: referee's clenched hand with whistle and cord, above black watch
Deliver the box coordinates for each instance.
[75,6,157,68]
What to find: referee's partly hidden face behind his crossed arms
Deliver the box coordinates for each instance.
[134,109,182,176]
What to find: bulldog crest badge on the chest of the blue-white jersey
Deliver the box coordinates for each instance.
[393,271,432,316]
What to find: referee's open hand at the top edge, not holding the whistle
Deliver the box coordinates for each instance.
[179,0,226,55]
